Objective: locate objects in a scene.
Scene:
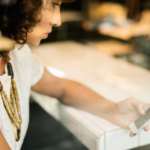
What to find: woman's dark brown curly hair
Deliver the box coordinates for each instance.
[0,0,74,44]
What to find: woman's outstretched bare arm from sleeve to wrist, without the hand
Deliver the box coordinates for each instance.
[32,69,116,121]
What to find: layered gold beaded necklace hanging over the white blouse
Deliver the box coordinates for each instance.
[0,36,22,141]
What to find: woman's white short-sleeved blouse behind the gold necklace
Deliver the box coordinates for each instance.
[0,45,44,150]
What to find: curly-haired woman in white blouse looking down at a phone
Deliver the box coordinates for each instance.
[0,0,150,150]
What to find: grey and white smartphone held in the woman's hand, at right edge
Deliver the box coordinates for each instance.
[129,108,150,135]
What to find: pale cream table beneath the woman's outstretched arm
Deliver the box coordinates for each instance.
[32,41,150,150]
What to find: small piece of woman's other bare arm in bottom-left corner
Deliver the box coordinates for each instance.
[0,130,11,150]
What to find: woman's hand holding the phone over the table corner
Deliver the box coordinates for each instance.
[112,98,150,137]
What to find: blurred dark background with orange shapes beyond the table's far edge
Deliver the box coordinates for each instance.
[42,0,150,69]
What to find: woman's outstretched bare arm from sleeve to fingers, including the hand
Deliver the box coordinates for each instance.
[32,69,150,128]
